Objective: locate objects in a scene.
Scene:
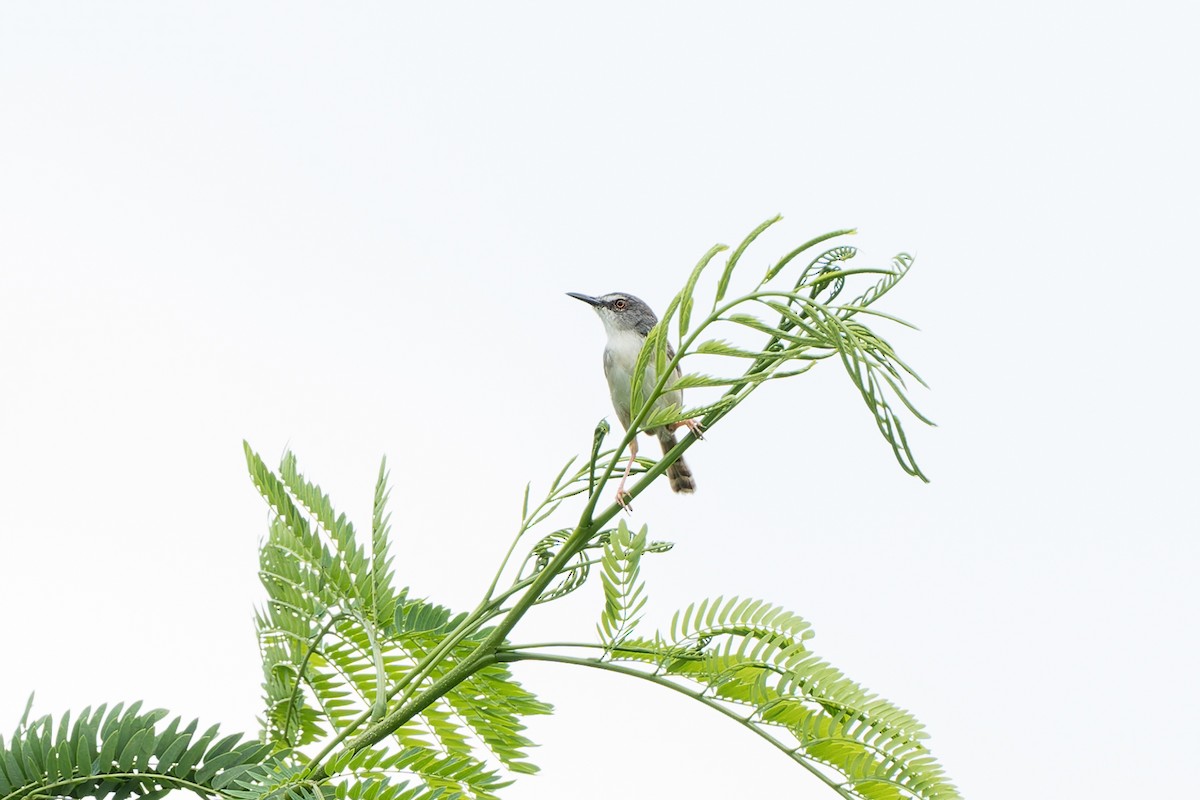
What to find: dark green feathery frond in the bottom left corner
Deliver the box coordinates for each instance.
[0,698,280,800]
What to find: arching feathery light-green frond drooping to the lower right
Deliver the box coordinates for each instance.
[597,597,959,800]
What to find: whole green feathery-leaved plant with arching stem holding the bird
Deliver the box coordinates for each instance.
[0,217,959,800]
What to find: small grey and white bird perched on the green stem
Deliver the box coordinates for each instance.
[566,291,702,506]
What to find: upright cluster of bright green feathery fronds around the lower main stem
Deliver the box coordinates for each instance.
[253,446,550,798]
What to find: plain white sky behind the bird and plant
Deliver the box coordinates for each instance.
[0,2,1200,798]
